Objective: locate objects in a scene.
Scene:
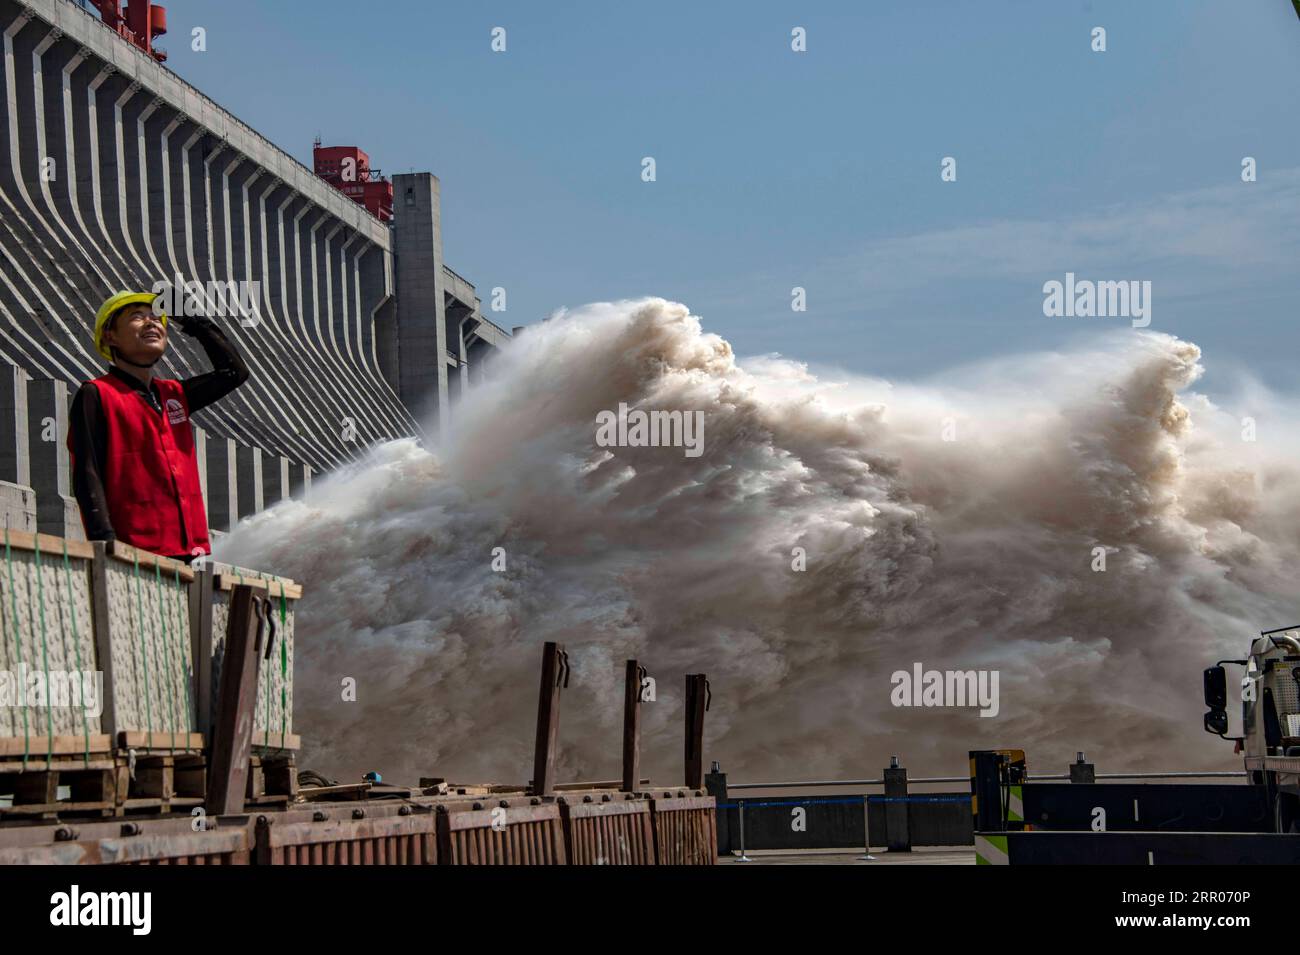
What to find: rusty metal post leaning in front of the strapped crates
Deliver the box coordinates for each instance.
[204,583,261,816]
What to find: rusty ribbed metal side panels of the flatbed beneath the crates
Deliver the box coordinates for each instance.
[0,791,718,865]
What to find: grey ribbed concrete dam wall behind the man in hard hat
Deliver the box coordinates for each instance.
[0,0,508,538]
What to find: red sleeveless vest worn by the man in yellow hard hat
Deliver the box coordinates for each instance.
[68,374,212,556]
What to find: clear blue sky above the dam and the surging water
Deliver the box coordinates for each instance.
[160,0,1300,392]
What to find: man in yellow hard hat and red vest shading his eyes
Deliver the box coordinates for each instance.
[68,292,248,563]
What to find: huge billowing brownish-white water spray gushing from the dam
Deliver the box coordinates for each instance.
[218,299,1300,782]
